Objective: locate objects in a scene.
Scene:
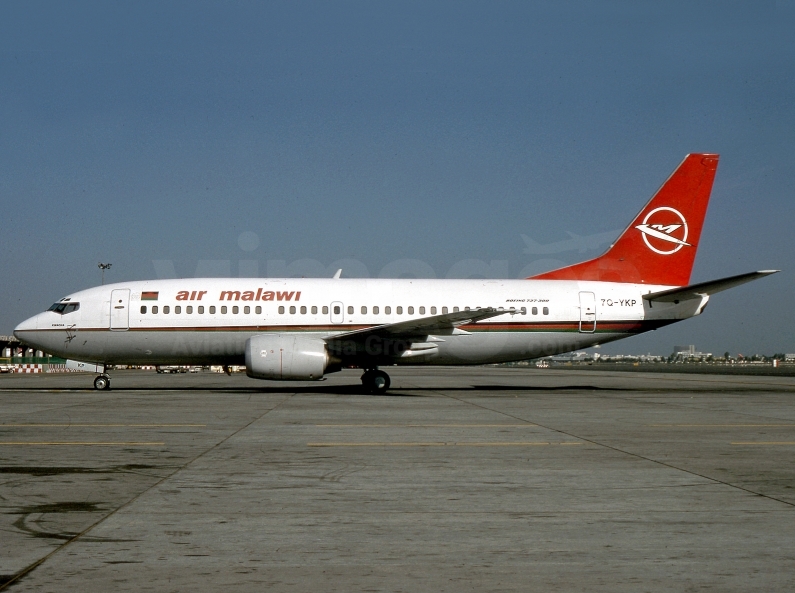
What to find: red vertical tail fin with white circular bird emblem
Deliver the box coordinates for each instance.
[532,154,718,286]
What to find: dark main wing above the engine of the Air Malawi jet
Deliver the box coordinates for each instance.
[325,307,511,345]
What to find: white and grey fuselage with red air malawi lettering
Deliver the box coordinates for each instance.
[15,278,708,365]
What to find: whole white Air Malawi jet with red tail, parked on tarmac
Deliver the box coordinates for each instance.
[14,154,778,394]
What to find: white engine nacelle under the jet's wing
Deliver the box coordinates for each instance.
[246,334,329,381]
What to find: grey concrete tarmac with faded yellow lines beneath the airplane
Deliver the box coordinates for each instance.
[0,367,795,592]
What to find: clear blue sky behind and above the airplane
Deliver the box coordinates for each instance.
[0,2,795,353]
